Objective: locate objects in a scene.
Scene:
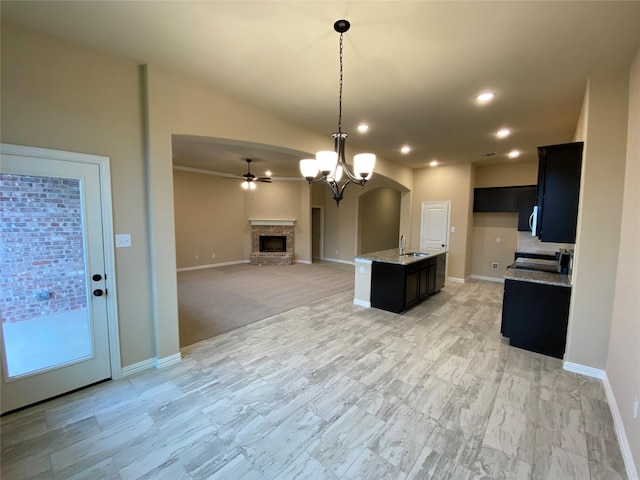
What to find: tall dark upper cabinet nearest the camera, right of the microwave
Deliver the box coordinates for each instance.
[536,142,583,243]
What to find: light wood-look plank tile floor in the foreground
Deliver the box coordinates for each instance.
[1,281,626,480]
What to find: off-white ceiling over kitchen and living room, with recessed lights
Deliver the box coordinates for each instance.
[0,0,640,177]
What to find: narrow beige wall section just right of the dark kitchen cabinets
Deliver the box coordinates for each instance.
[565,72,629,370]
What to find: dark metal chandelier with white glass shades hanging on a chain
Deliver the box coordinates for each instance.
[300,20,376,205]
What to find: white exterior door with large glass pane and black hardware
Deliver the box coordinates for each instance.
[0,153,111,413]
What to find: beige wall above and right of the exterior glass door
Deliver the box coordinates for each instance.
[0,23,154,367]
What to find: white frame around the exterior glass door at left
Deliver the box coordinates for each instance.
[0,143,122,380]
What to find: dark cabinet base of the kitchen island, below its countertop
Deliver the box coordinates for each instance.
[371,253,446,313]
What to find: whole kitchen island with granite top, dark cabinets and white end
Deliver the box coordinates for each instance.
[353,248,446,313]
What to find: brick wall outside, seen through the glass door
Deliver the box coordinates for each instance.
[0,174,87,322]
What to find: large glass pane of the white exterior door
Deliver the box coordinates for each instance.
[0,174,93,378]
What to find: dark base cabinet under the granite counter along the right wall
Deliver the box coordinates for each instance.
[500,280,571,358]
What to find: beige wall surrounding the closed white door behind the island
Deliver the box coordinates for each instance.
[409,164,473,280]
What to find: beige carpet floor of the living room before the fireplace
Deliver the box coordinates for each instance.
[178,262,354,347]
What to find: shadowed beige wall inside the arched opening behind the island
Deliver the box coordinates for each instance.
[356,188,401,254]
